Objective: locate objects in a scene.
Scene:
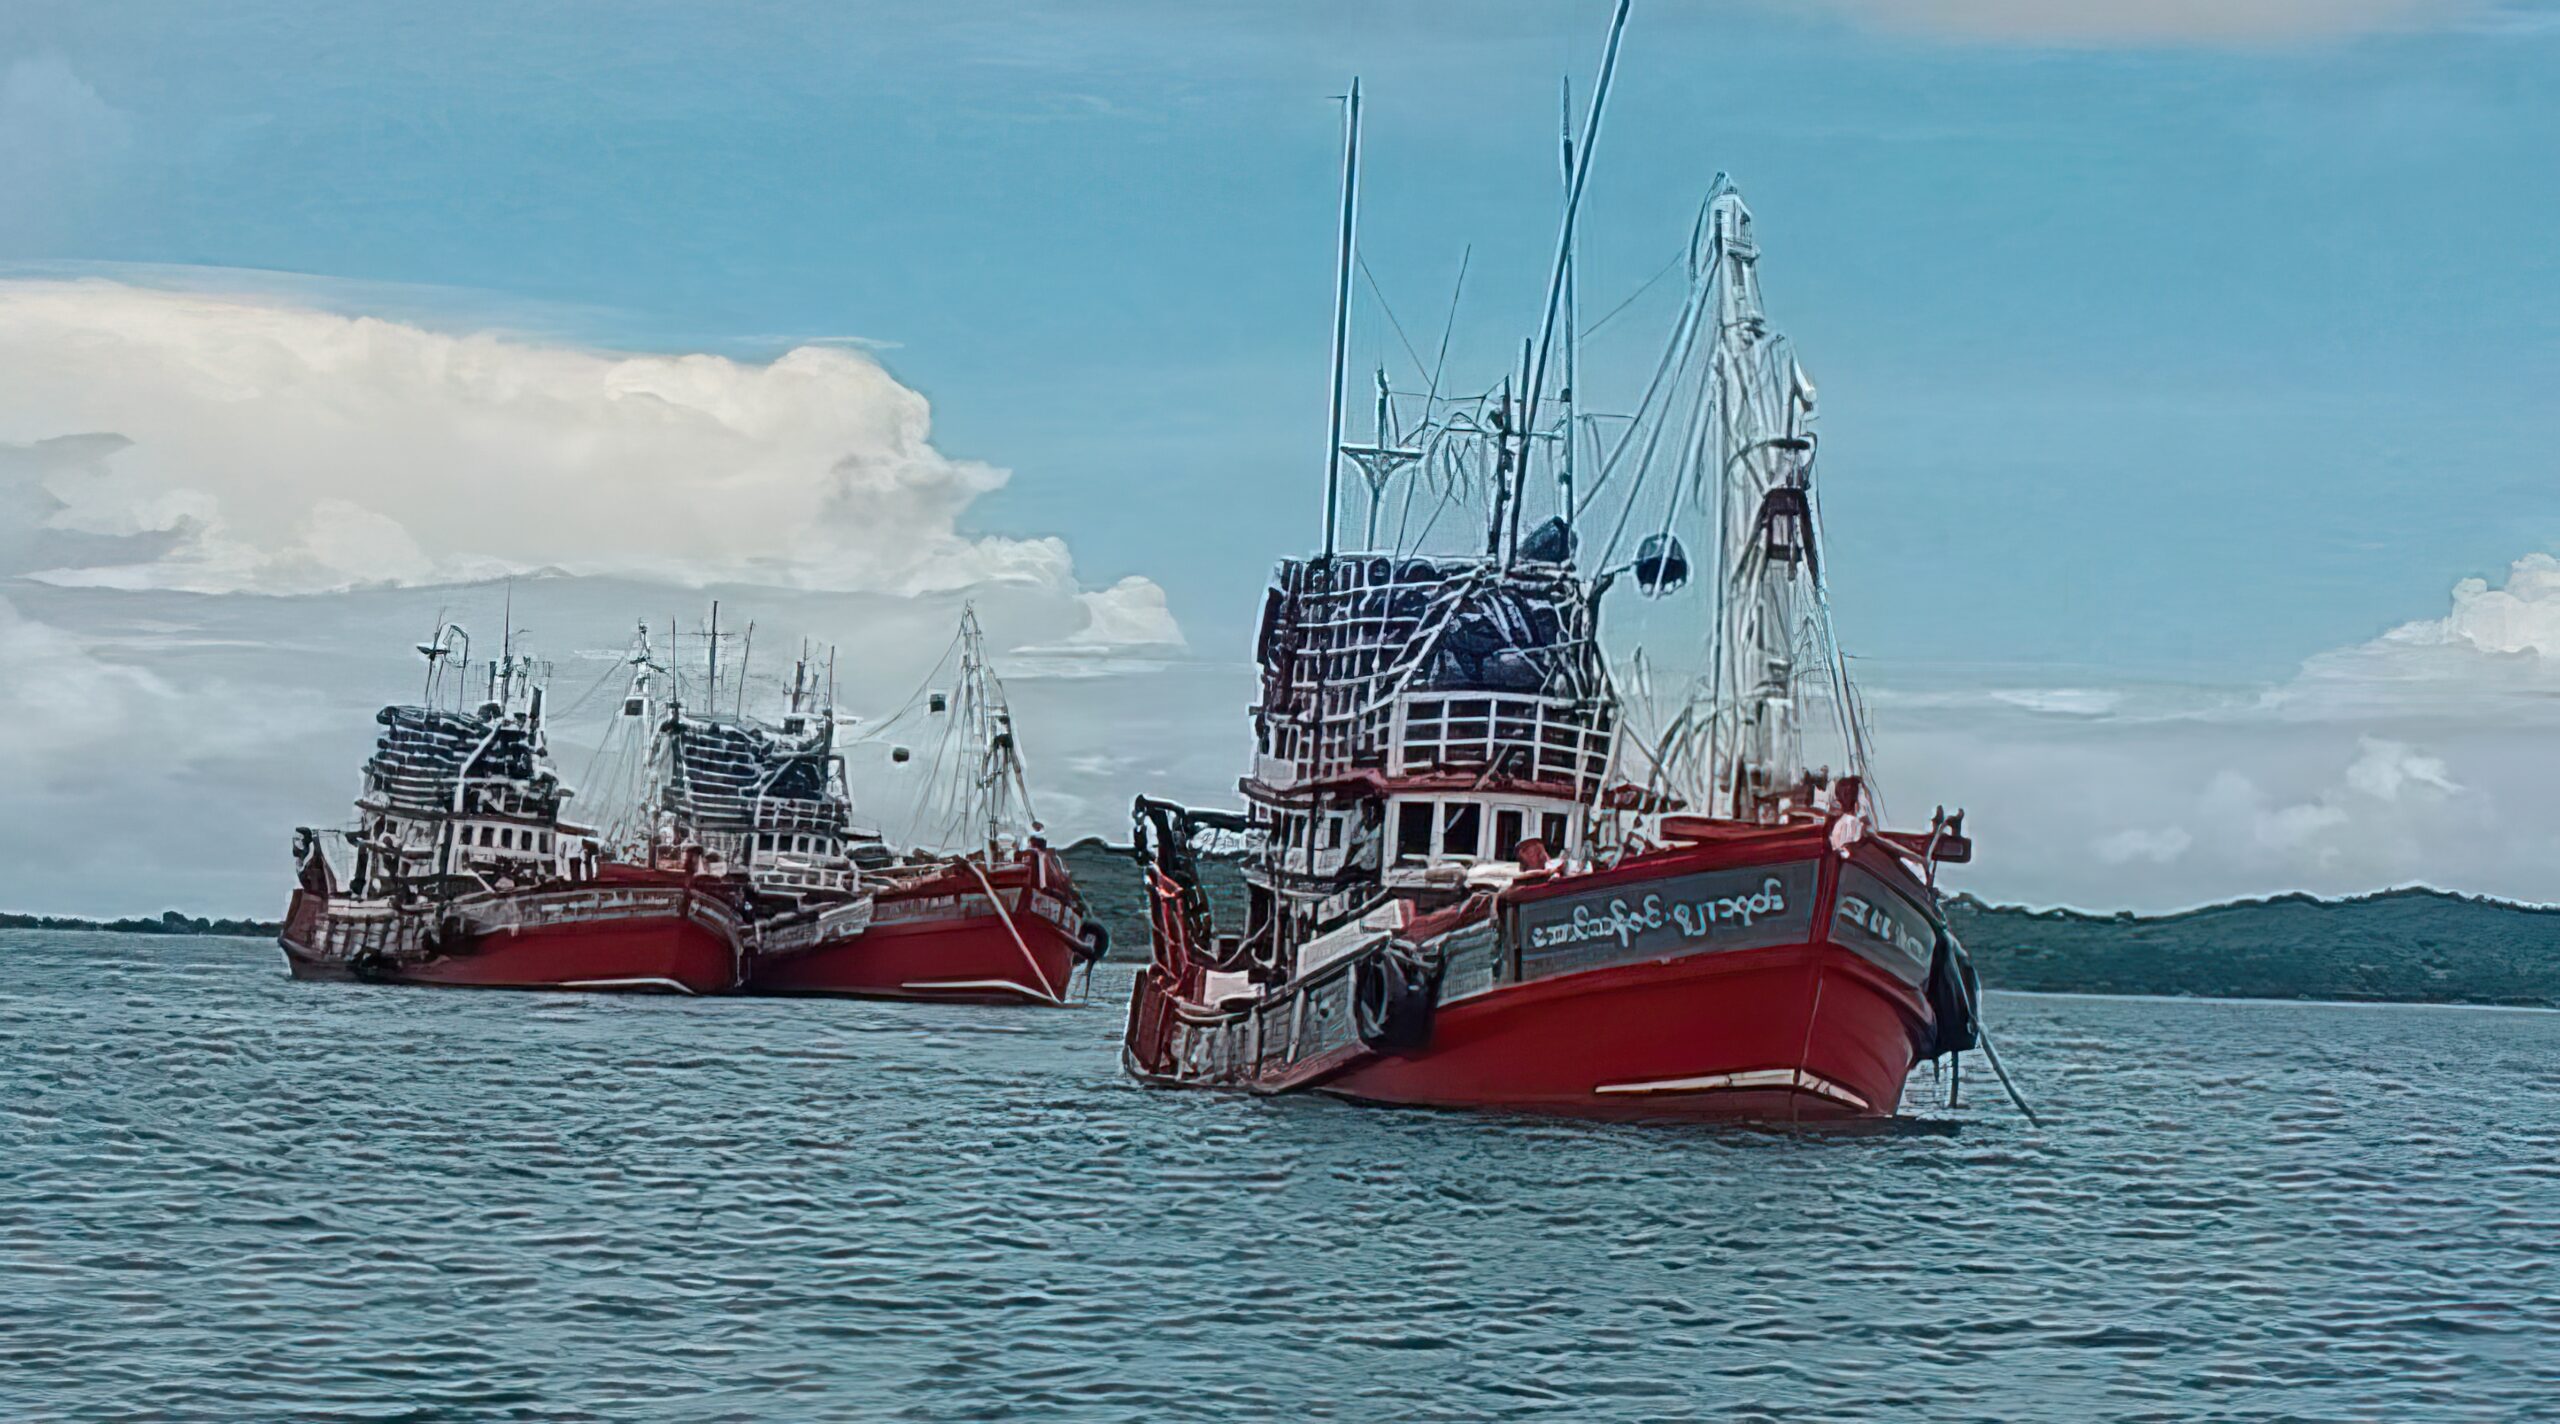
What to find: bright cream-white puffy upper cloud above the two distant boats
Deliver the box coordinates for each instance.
[0,279,1178,643]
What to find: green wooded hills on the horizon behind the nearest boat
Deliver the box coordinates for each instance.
[1068,840,2560,1007]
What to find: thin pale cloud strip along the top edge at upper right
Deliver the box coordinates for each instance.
[1828,0,2483,46]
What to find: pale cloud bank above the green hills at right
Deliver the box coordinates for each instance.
[1874,553,2560,909]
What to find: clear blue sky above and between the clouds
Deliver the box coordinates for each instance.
[0,0,2560,902]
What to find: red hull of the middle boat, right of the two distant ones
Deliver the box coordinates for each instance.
[748,853,1080,1004]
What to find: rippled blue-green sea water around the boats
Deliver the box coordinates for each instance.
[0,932,2560,1421]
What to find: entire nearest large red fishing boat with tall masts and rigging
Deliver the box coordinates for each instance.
[1124,8,1997,1122]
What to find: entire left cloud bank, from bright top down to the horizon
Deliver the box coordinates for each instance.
[0,274,1203,914]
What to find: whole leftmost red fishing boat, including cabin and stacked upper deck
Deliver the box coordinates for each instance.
[282,622,742,994]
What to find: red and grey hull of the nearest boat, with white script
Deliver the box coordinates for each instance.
[1126,827,1935,1122]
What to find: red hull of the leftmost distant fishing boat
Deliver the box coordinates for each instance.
[284,886,742,994]
